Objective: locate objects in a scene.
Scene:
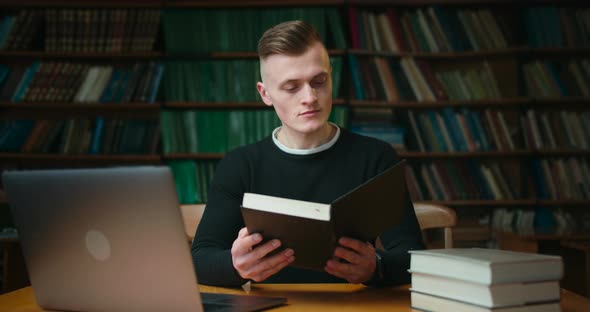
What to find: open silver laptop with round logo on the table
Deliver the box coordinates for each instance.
[3,167,285,311]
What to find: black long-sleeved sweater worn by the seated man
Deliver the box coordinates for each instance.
[192,129,424,287]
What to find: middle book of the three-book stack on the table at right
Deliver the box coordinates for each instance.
[411,272,559,308]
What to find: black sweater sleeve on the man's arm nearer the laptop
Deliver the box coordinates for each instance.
[191,153,247,287]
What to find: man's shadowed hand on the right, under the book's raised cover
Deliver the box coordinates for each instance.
[324,237,376,284]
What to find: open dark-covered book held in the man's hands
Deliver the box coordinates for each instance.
[242,161,406,270]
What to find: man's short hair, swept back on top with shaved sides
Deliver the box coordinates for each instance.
[258,21,322,60]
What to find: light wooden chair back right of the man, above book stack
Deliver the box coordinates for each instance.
[414,203,457,248]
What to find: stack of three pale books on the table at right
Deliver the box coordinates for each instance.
[410,248,563,312]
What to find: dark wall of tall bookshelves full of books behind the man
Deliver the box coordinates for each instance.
[0,0,590,264]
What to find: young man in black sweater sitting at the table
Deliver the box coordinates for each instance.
[192,21,423,286]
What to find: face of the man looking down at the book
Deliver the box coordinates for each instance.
[257,42,332,135]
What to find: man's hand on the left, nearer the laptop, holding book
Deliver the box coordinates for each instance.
[231,227,295,282]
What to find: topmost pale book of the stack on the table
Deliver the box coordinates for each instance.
[409,248,563,285]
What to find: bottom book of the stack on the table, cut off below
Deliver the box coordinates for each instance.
[411,291,561,312]
